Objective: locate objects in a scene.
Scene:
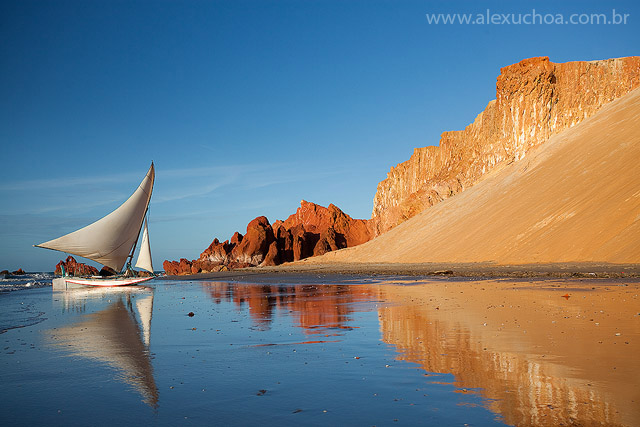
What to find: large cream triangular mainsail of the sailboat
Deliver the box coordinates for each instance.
[36,163,155,271]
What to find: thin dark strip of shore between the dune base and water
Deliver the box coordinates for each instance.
[158,261,640,281]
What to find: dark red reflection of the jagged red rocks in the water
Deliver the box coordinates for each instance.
[203,282,369,334]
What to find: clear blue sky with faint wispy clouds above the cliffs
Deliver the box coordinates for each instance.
[0,0,640,271]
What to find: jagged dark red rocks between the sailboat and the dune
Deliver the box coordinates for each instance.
[162,200,373,275]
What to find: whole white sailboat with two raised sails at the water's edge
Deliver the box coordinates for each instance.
[35,162,155,290]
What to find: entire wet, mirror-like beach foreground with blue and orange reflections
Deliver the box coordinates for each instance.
[0,276,640,426]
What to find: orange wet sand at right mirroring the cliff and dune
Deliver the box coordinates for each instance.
[370,280,640,425]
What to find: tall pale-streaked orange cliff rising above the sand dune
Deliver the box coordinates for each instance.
[372,57,640,235]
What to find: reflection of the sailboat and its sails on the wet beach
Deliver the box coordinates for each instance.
[50,288,158,407]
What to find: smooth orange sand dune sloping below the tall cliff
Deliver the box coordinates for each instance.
[316,89,640,264]
